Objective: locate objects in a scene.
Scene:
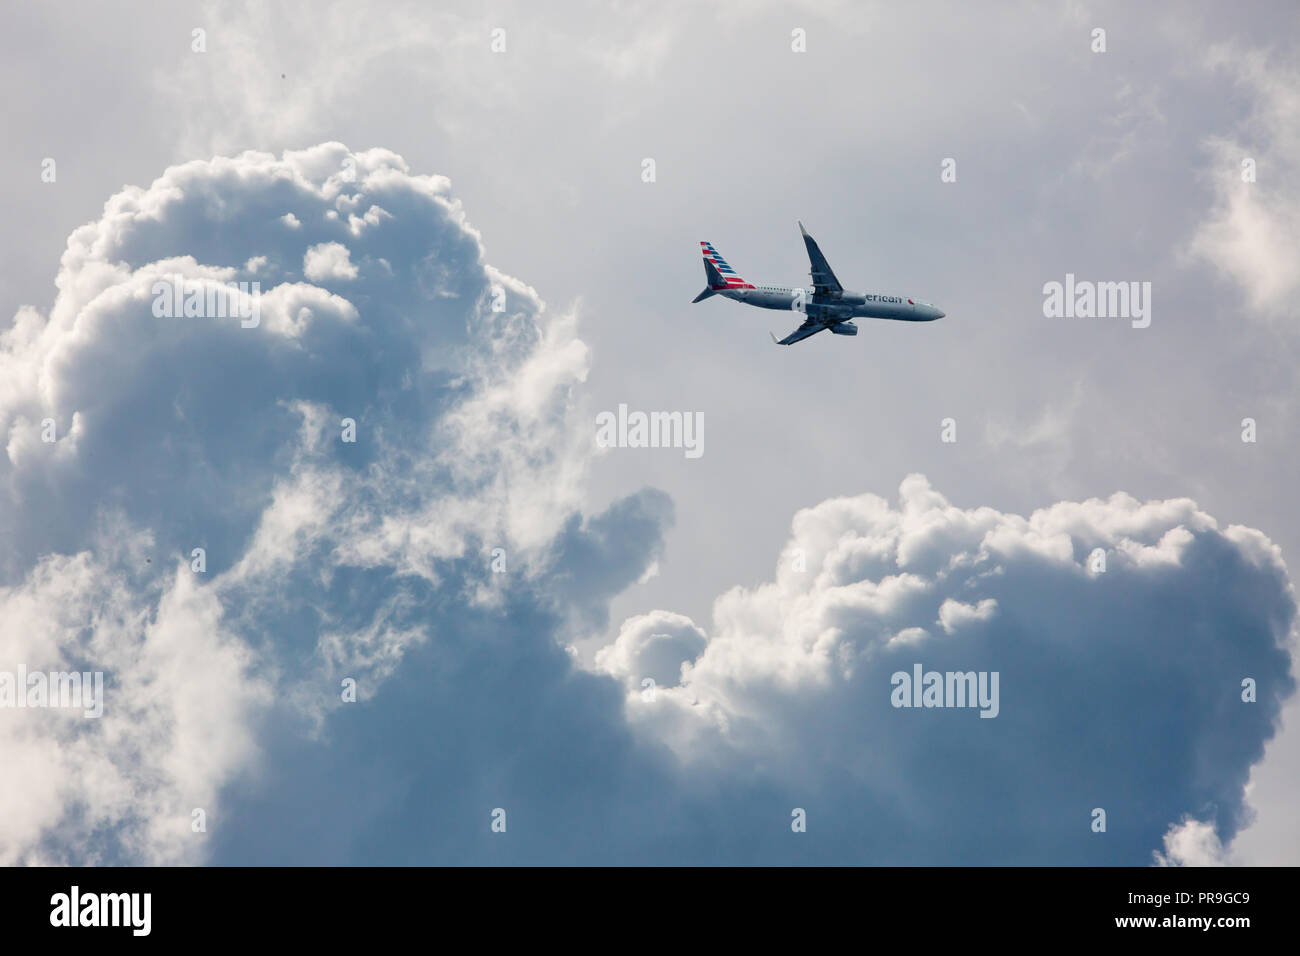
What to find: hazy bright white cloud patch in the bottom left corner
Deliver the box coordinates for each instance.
[0,527,269,865]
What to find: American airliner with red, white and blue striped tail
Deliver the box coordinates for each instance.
[692,222,945,345]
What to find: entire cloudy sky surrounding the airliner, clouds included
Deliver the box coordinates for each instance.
[0,3,1300,865]
